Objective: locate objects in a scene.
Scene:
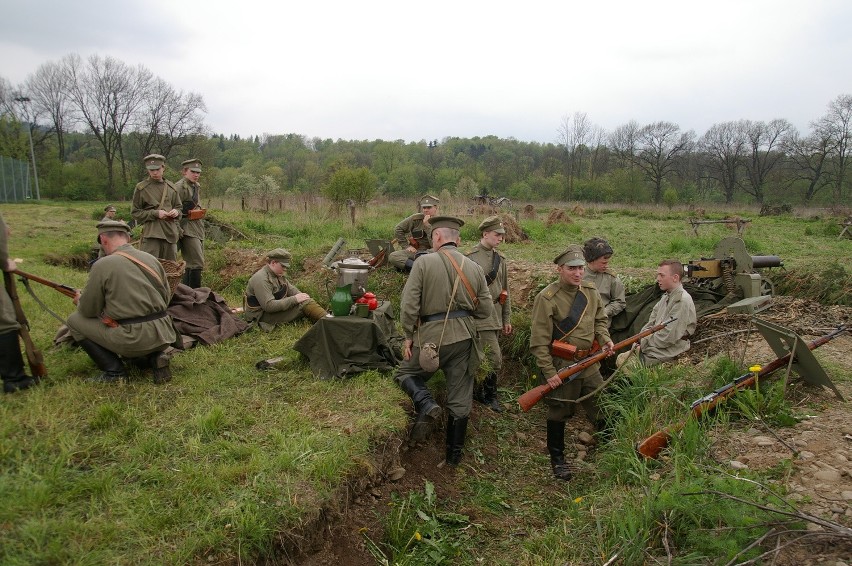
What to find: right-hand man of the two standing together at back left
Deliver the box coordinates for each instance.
[175,159,204,289]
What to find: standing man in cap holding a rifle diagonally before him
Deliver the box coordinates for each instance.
[530,245,614,481]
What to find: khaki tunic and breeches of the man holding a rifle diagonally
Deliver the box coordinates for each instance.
[530,281,610,412]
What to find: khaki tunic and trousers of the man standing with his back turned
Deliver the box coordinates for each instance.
[394,244,493,418]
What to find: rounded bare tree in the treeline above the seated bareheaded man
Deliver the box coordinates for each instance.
[635,122,695,203]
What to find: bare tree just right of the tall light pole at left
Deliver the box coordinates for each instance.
[25,61,73,162]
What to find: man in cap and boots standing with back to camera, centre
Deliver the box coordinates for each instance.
[394,216,493,465]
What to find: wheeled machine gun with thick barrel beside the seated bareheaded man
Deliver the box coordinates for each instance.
[683,236,784,314]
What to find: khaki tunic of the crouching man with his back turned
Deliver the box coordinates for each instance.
[68,244,177,358]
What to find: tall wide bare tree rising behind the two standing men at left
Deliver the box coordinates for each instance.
[63,54,152,197]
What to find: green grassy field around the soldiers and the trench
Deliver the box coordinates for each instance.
[0,202,852,564]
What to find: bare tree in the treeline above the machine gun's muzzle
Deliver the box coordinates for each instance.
[742,119,793,205]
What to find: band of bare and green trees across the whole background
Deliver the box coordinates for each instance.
[0,54,852,209]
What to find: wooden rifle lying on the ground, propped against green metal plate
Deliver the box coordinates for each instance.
[636,325,846,458]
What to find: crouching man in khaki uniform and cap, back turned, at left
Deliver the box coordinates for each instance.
[68,220,177,383]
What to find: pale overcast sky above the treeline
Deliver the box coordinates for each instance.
[0,0,852,143]
